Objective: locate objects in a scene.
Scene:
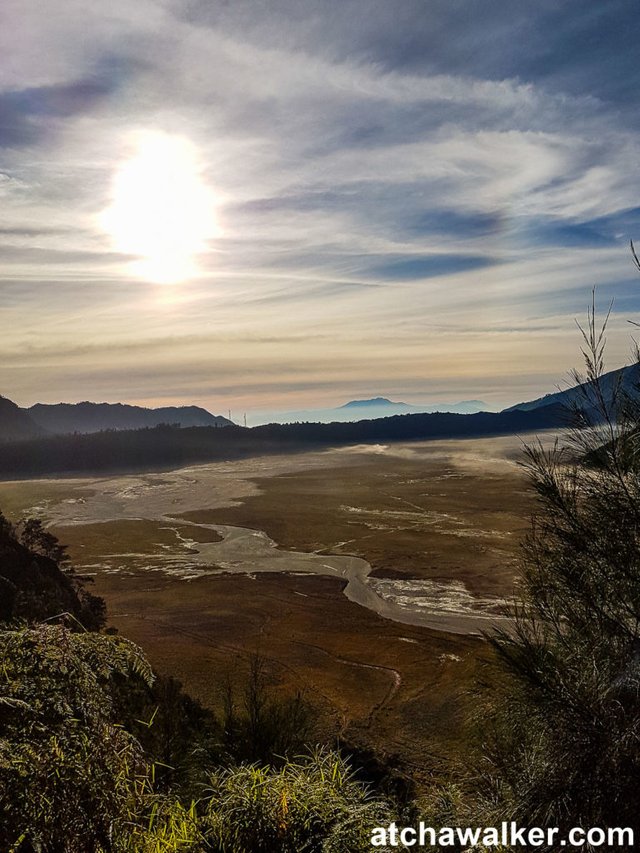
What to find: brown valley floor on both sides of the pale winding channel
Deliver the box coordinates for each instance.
[0,438,552,773]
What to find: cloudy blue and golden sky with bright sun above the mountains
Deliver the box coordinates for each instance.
[0,0,640,419]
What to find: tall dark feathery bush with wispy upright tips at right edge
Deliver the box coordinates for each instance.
[484,298,640,832]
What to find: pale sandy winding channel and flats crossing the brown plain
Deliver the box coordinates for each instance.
[0,434,555,633]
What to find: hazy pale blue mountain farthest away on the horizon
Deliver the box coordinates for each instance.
[248,397,489,426]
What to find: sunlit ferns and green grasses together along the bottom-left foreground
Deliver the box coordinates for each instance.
[0,625,398,853]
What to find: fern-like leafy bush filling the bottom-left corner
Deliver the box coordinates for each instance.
[0,625,152,853]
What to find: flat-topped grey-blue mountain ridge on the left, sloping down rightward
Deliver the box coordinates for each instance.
[26,402,231,434]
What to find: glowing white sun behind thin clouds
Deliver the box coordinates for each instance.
[100,131,219,284]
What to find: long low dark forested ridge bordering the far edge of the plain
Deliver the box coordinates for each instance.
[0,406,567,479]
